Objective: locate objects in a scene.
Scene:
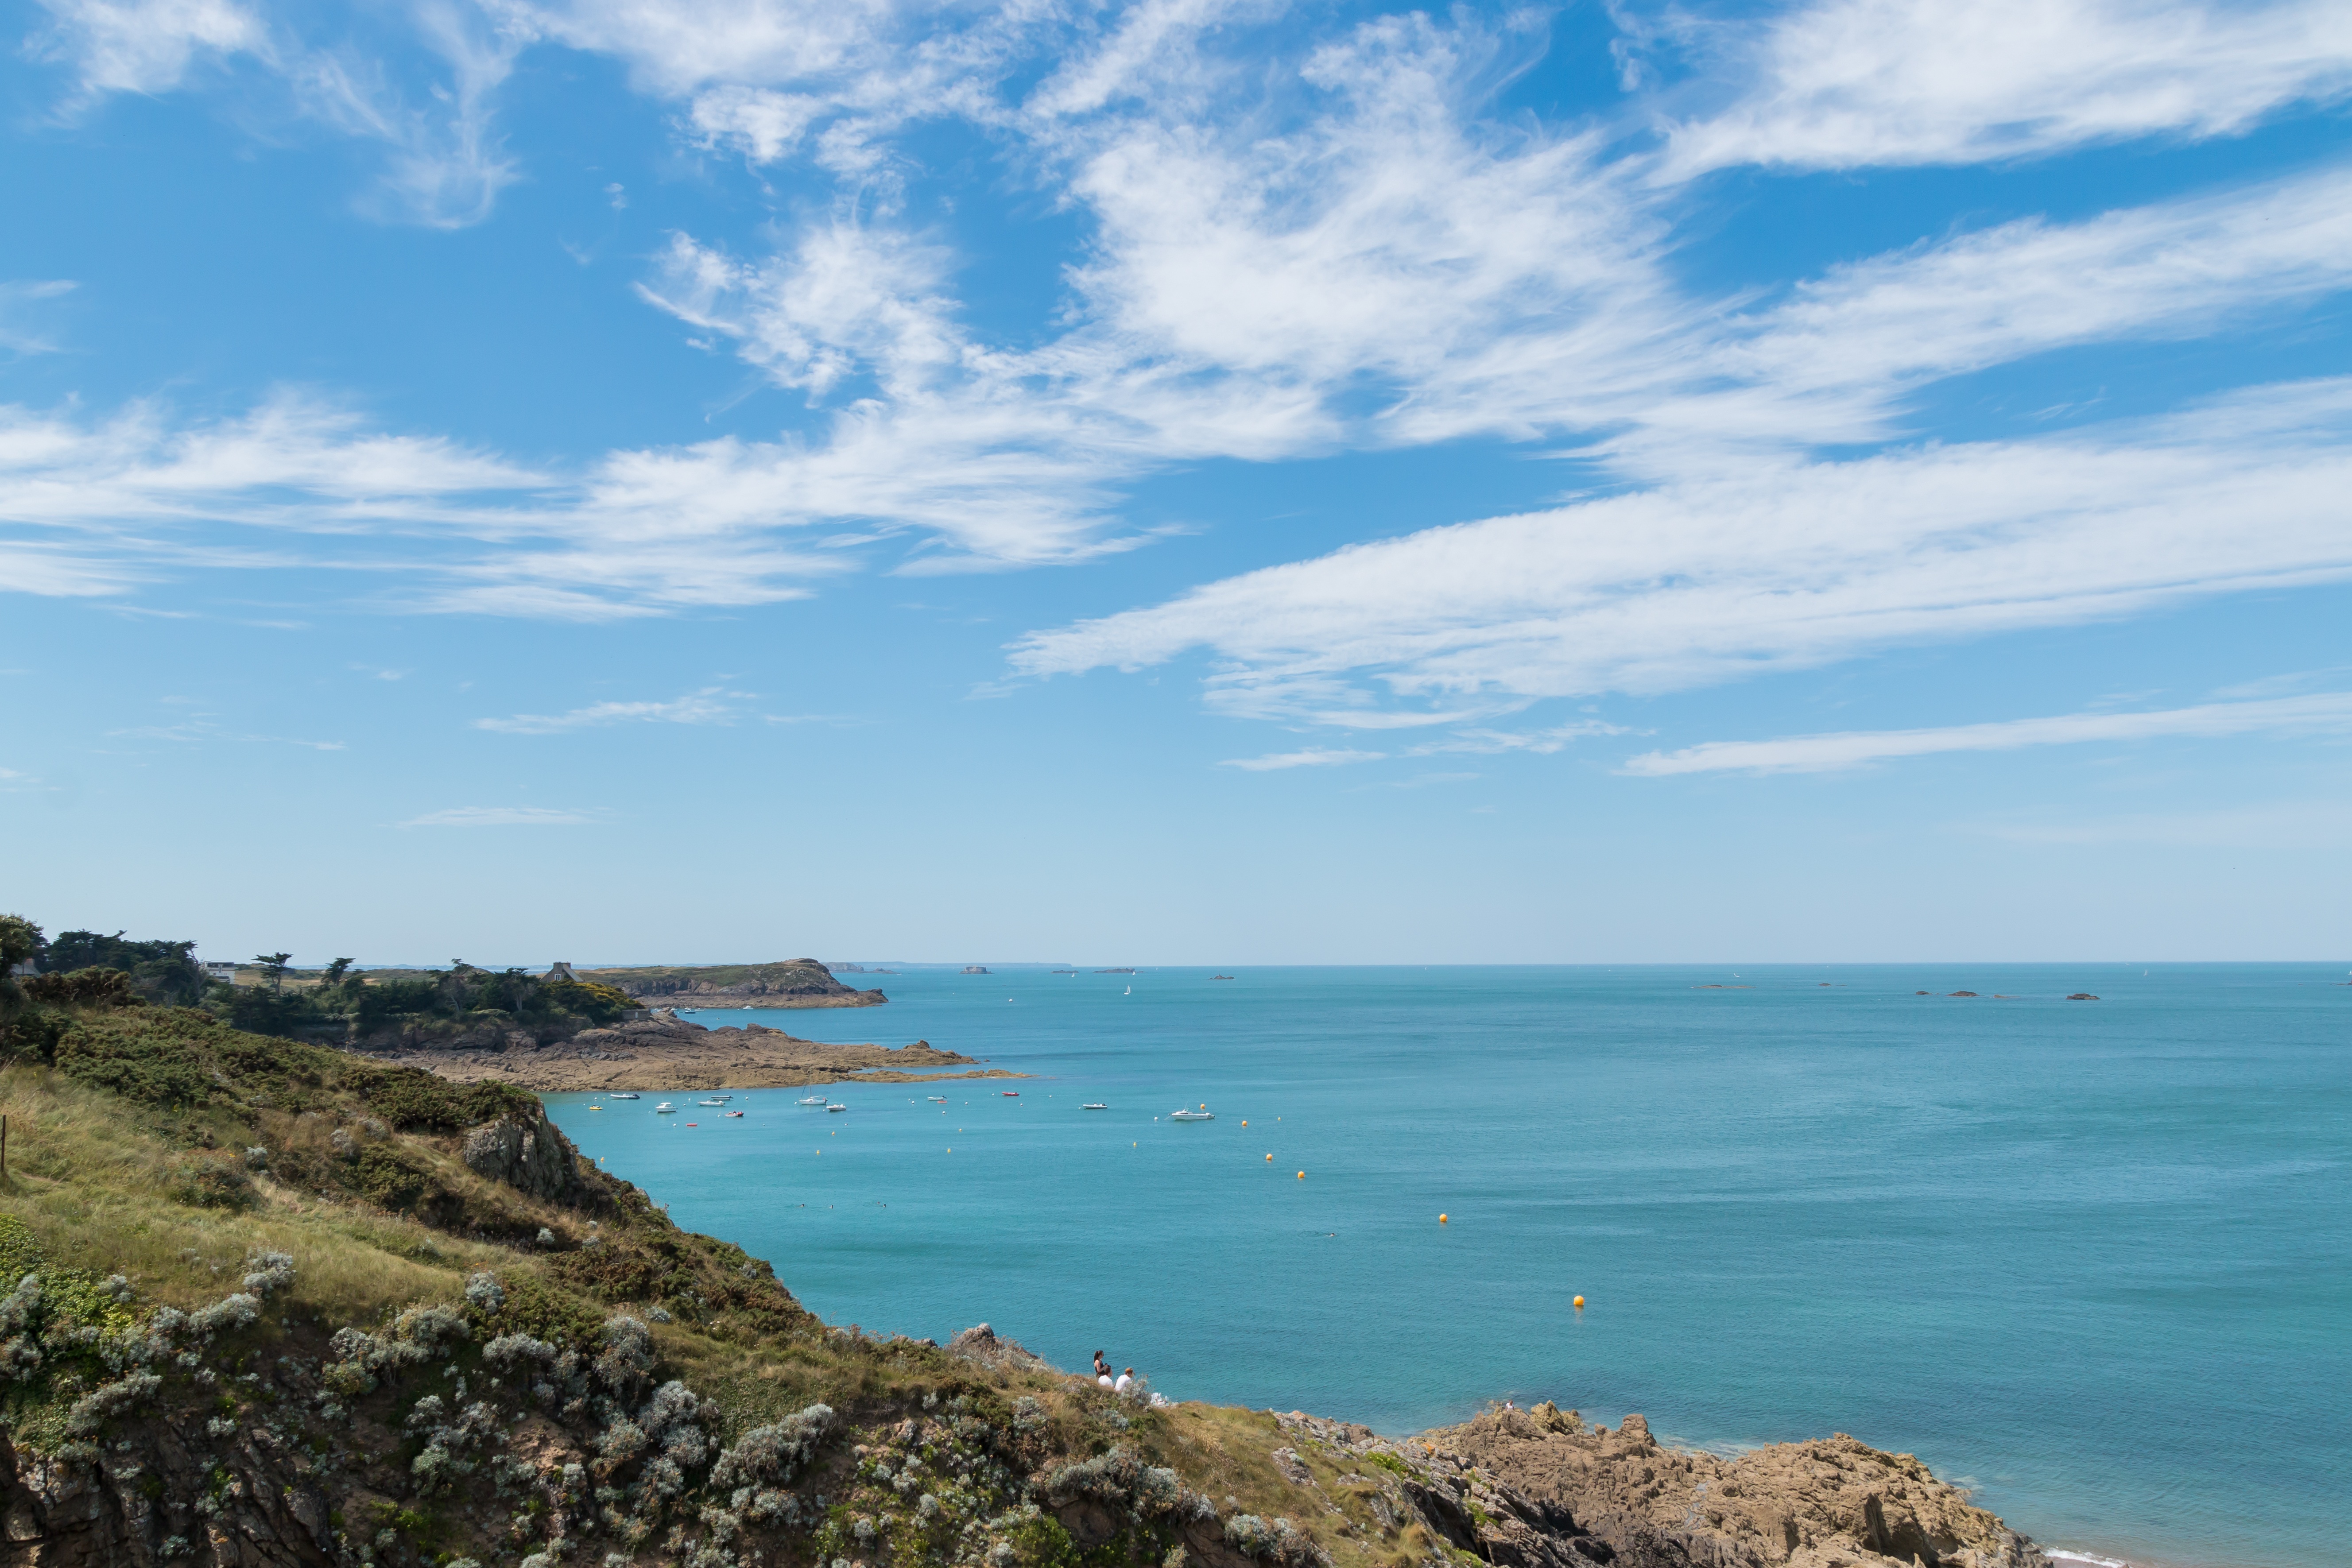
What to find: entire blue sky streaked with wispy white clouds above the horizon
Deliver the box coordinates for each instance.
[0,0,2352,964]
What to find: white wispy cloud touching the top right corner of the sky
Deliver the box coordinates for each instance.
[1663,0,2352,176]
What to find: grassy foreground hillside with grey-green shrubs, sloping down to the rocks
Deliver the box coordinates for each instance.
[0,983,1505,1568]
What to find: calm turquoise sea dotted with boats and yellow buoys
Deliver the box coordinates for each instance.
[550,964,2352,1568]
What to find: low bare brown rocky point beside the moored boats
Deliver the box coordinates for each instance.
[369,1011,1028,1093]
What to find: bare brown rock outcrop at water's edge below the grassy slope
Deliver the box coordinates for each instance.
[1428,1408,2049,1568]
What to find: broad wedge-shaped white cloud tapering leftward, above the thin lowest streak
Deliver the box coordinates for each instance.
[1011,381,2352,724]
